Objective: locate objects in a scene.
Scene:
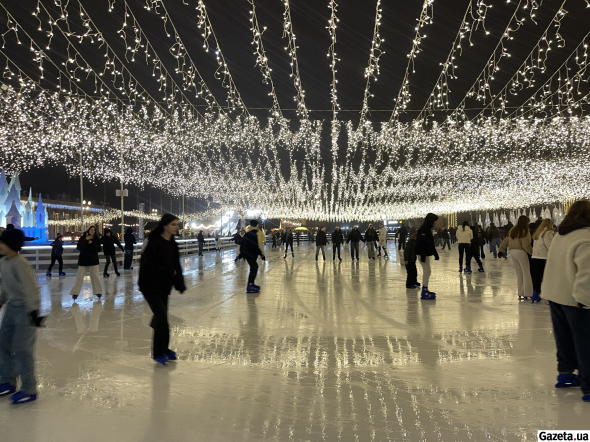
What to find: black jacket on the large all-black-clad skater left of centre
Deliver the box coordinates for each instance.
[137,235,186,294]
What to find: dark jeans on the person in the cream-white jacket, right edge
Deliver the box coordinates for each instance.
[549,301,590,394]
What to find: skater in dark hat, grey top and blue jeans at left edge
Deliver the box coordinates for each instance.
[0,229,43,405]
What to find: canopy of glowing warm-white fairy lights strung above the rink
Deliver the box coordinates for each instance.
[0,0,590,221]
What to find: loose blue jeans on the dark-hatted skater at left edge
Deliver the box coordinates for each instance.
[0,302,37,394]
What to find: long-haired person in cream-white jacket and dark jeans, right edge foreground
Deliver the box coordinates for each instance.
[541,201,590,402]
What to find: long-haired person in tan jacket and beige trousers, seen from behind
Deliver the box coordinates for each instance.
[498,215,541,302]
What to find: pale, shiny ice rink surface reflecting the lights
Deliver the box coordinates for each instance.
[0,244,590,442]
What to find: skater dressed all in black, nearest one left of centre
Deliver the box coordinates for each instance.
[137,213,186,365]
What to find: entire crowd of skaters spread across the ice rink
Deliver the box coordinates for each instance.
[0,201,590,404]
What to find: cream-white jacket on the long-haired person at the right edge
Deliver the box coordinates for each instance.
[541,227,590,308]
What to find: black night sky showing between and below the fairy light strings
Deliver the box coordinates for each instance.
[0,0,590,207]
